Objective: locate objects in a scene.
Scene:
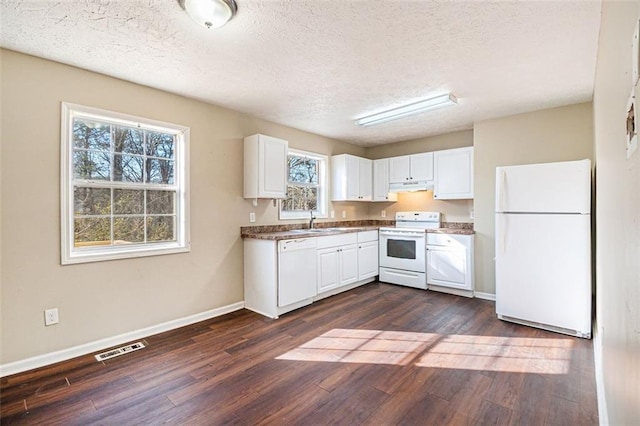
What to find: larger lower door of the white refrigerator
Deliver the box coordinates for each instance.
[496,214,591,335]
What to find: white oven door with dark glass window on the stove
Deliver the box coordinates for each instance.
[380,230,426,272]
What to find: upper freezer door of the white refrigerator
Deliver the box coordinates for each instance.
[496,160,591,214]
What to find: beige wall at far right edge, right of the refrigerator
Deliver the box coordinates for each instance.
[593,1,640,425]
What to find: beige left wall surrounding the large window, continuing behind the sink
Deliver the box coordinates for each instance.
[0,50,368,364]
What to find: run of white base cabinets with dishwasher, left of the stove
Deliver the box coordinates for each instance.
[244,230,378,318]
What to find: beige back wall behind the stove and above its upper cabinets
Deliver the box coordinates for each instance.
[366,130,473,222]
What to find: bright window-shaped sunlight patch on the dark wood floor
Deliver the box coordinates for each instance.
[276,329,573,374]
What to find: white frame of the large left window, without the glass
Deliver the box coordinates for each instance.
[60,102,191,265]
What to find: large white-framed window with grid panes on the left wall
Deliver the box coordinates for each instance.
[61,102,189,264]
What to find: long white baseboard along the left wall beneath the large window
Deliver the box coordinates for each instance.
[0,301,244,377]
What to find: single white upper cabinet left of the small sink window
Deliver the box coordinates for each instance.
[244,134,289,198]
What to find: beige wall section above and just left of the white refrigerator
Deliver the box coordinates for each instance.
[474,102,593,294]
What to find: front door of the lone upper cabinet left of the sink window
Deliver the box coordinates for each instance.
[258,135,288,198]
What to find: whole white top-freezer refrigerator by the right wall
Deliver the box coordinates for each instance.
[495,160,592,338]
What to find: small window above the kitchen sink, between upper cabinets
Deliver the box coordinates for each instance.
[280,150,327,219]
